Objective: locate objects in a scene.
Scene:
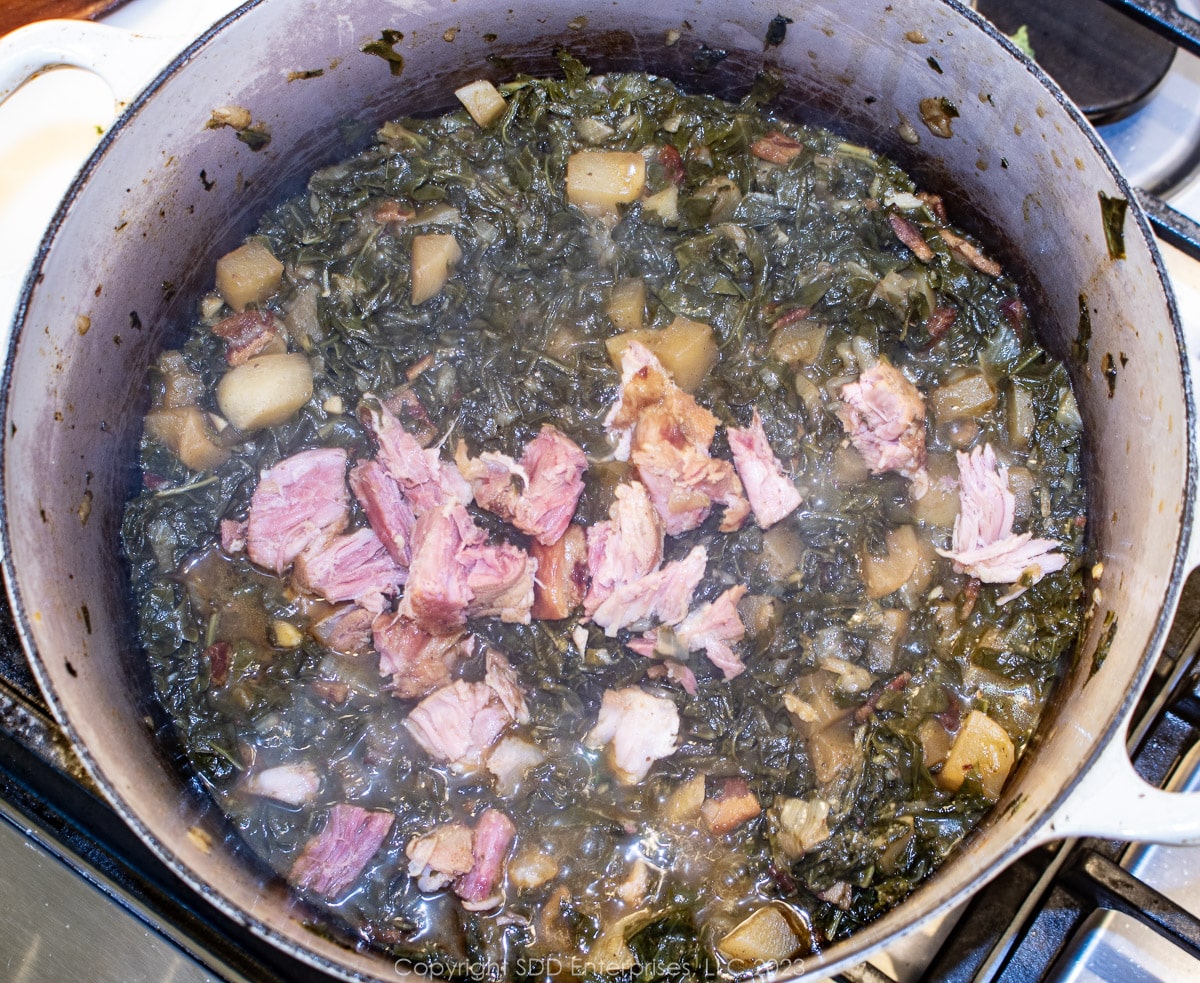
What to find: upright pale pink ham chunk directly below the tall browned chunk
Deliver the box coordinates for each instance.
[583,481,665,617]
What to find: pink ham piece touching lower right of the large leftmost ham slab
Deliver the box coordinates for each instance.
[292,528,402,613]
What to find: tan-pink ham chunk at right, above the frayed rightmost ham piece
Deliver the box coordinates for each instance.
[838,361,929,498]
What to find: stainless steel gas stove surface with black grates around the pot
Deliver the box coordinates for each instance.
[0,0,1200,983]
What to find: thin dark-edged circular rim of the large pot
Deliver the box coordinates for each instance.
[0,0,1200,981]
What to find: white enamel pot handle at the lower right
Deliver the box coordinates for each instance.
[1038,724,1200,846]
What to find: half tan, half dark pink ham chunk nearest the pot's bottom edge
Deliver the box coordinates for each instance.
[404,809,516,911]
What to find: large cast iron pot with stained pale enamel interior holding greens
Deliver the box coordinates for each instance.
[0,0,1200,979]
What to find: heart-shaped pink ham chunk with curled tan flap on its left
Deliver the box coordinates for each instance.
[455,424,588,546]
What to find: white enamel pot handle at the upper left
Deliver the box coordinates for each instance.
[0,20,179,114]
